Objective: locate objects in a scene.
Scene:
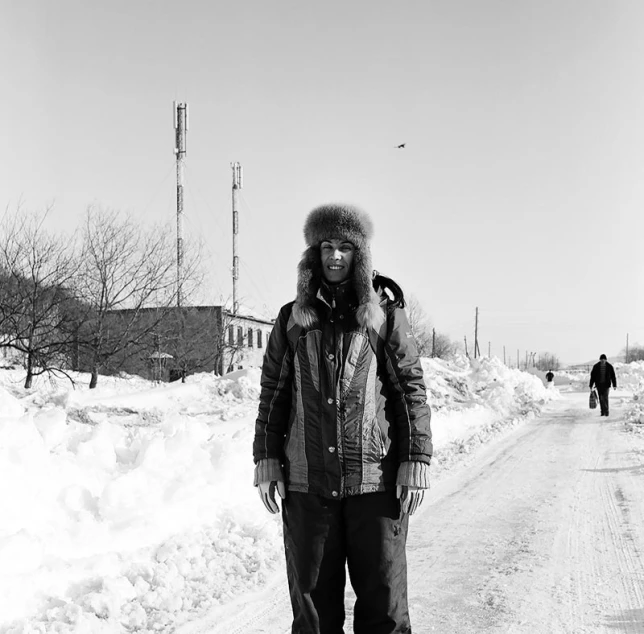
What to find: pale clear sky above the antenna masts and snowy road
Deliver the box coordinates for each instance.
[0,0,644,363]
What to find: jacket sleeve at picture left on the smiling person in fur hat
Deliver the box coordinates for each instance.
[253,304,293,465]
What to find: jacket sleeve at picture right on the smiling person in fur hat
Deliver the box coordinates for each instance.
[385,308,433,464]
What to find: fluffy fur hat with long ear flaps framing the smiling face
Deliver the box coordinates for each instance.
[293,203,384,329]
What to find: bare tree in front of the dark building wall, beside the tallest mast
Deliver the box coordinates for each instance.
[73,207,195,388]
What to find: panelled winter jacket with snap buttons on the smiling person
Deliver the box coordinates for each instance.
[253,285,432,498]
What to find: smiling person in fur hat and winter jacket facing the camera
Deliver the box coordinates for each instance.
[253,204,432,634]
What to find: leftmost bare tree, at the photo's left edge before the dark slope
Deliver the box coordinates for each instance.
[0,206,78,388]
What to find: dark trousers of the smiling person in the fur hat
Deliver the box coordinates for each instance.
[282,491,411,634]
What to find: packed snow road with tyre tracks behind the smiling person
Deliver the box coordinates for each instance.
[180,393,644,634]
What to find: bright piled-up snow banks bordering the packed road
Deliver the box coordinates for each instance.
[0,358,644,634]
